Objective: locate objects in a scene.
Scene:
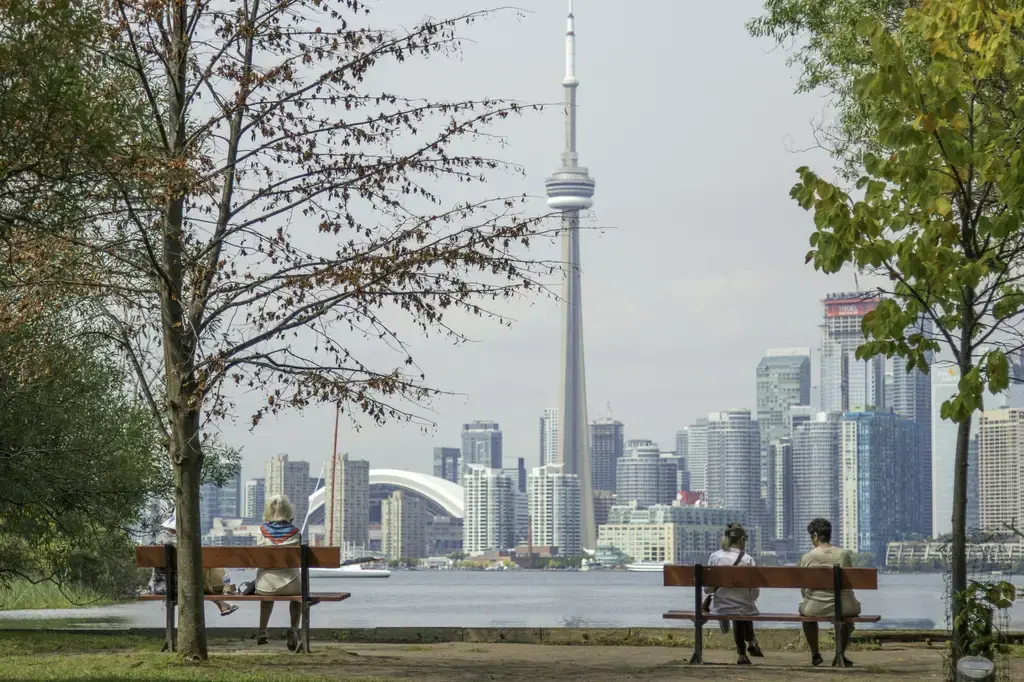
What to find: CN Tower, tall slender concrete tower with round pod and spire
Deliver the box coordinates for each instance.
[546,0,597,549]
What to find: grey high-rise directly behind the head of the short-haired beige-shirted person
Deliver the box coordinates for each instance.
[792,412,843,547]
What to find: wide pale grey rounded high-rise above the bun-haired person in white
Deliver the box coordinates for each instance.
[704,410,765,528]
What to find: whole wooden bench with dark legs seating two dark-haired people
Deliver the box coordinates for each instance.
[662,564,882,668]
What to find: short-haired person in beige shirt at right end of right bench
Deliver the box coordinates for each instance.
[800,518,860,668]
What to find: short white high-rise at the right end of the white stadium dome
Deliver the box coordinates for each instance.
[462,465,516,555]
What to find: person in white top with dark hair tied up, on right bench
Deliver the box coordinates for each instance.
[705,523,764,666]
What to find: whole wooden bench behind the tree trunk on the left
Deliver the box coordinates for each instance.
[135,545,351,653]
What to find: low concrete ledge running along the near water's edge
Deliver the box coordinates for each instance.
[6,624,1024,648]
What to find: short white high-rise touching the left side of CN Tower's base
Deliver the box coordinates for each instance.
[527,464,582,556]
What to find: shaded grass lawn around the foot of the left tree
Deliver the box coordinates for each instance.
[0,631,386,682]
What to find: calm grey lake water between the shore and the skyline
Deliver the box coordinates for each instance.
[0,571,1024,629]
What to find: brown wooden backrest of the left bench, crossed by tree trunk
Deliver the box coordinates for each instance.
[135,545,341,568]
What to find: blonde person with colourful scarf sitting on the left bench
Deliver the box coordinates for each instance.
[256,495,302,651]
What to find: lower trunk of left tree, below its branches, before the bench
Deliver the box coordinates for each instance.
[171,411,207,660]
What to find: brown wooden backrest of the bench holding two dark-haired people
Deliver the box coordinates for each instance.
[665,566,879,590]
